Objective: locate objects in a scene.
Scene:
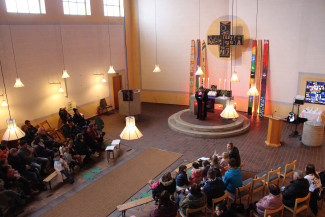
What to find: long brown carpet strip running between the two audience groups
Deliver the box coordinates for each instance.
[42,148,181,217]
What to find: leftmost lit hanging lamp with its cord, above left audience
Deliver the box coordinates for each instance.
[0,60,25,141]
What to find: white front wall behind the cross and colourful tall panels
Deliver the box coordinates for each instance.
[138,0,325,105]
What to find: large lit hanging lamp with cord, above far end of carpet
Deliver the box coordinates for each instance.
[120,7,143,140]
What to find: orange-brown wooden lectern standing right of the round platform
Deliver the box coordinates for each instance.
[265,117,283,148]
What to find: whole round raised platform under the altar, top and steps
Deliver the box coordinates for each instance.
[168,109,250,138]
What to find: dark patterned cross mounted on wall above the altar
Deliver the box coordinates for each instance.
[208,21,244,57]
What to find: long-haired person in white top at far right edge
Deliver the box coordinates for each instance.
[305,164,322,216]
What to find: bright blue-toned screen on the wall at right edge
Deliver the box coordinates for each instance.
[305,81,325,105]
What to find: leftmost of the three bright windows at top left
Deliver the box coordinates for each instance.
[6,0,46,14]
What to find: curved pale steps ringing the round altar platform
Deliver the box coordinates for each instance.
[168,109,250,138]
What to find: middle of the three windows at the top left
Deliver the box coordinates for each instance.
[63,0,91,15]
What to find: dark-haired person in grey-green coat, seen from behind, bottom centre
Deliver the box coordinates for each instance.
[179,183,207,214]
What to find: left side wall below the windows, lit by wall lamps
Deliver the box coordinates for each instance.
[0,23,126,128]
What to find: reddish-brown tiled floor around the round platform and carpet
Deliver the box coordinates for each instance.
[24,103,325,217]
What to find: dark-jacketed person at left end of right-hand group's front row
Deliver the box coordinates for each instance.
[152,172,176,200]
